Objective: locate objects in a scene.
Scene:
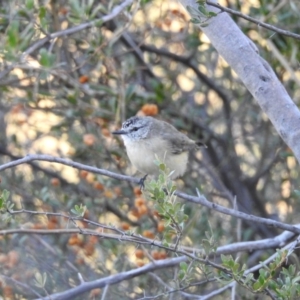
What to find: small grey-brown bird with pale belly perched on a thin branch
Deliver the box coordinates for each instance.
[112,116,202,180]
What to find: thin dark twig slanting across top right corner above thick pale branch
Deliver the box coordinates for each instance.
[206,1,300,40]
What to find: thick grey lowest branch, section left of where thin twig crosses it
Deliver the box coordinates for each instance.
[36,256,187,300]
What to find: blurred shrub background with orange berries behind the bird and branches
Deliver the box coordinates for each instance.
[0,0,300,299]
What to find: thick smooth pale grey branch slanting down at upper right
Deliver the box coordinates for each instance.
[180,0,300,163]
